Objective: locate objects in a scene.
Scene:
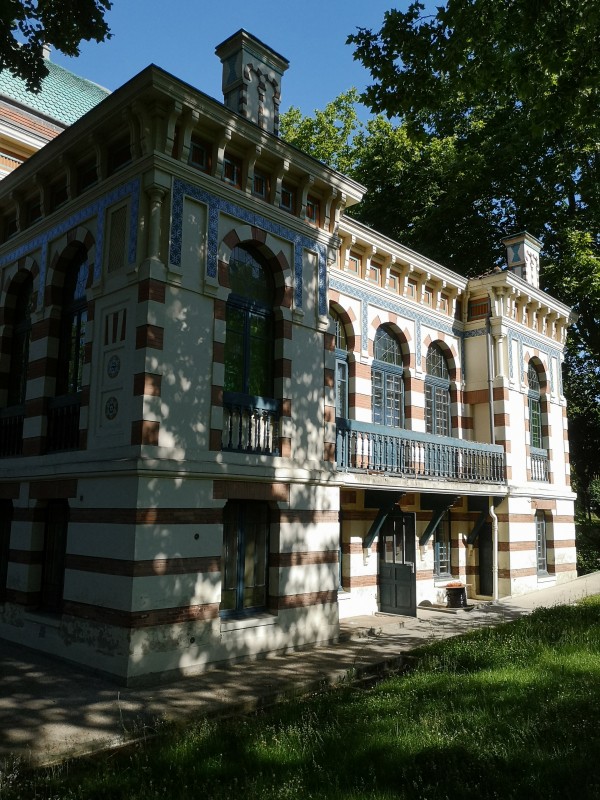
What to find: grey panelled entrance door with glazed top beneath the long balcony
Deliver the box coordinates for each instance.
[379,511,417,617]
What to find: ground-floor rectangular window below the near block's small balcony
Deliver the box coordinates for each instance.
[220,500,269,616]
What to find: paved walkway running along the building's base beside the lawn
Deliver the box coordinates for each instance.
[0,572,600,764]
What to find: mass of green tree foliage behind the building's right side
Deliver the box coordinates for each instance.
[282,0,600,500]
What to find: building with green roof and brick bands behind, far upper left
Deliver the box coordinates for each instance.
[0,50,109,180]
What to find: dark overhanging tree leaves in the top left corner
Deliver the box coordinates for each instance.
[0,0,112,91]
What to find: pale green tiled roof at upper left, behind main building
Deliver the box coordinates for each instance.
[0,61,110,125]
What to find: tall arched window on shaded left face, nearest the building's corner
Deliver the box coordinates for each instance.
[47,246,89,452]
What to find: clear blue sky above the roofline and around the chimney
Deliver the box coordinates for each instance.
[51,0,409,122]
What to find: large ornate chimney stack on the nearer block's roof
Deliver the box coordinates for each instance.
[215,29,289,136]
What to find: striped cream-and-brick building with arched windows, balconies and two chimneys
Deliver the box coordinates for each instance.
[0,31,576,684]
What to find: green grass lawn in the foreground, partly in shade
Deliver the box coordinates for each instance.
[0,597,600,800]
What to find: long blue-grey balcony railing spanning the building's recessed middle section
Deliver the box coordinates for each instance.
[336,418,506,484]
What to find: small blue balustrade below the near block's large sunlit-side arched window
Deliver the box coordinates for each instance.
[222,392,280,456]
